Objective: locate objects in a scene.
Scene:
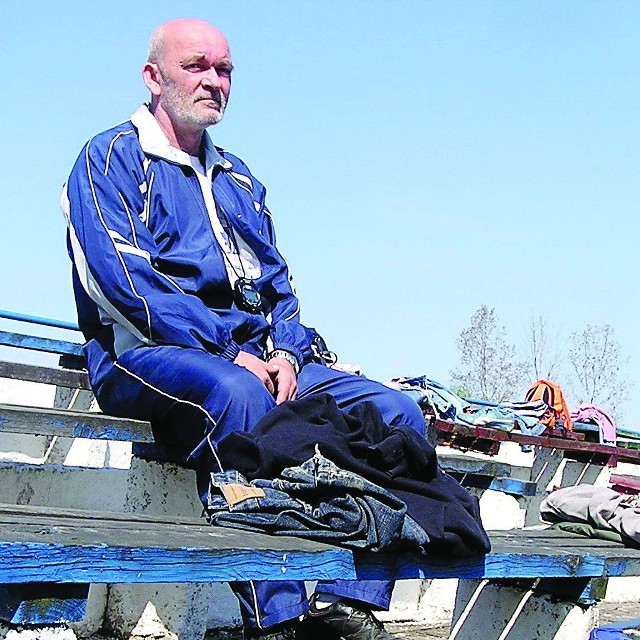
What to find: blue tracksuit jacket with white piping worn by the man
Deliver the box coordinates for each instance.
[62,107,311,385]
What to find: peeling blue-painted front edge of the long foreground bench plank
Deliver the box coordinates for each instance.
[0,542,640,583]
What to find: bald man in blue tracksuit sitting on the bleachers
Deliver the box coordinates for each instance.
[62,19,424,640]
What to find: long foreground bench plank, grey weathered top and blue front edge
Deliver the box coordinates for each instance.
[0,505,640,583]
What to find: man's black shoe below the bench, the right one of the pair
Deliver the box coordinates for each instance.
[305,594,401,640]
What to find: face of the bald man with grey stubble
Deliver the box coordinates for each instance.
[158,26,233,128]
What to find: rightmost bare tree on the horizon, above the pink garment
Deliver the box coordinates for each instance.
[569,324,631,420]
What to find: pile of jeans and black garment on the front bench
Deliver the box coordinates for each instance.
[208,394,490,557]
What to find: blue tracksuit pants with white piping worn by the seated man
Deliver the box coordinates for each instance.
[96,346,425,628]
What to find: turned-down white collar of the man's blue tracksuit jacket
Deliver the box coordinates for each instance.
[131,104,232,173]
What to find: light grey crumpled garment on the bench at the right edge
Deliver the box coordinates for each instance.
[540,484,640,544]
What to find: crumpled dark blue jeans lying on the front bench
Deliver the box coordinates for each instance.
[208,451,429,551]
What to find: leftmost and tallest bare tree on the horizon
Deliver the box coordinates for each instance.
[451,305,525,402]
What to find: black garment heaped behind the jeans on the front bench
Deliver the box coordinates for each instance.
[218,394,490,556]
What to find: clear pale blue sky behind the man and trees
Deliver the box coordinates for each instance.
[0,0,640,423]
